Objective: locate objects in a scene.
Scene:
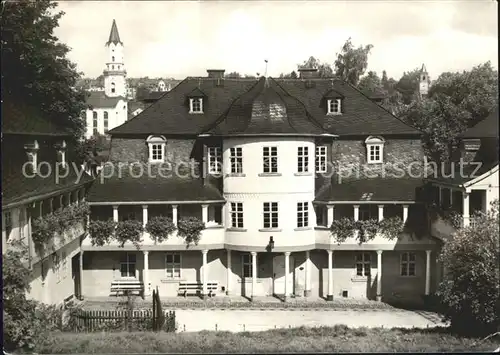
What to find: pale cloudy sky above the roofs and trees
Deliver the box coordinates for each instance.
[55,0,498,79]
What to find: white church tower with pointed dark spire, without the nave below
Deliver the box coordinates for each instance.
[103,20,127,97]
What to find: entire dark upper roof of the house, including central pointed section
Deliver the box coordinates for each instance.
[109,77,420,136]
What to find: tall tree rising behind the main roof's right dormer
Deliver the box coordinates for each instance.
[335,38,373,86]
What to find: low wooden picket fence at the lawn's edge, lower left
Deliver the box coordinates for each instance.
[69,309,176,332]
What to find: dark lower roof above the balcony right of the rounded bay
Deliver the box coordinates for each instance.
[316,178,424,202]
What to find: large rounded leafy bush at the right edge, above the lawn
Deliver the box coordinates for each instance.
[437,200,500,335]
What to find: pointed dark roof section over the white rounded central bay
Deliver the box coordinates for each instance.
[207,78,327,135]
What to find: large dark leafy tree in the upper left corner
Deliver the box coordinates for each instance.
[1,0,85,139]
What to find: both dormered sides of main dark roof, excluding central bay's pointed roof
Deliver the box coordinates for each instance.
[109,77,420,136]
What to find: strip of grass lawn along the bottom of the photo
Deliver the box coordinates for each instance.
[35,325,500,354]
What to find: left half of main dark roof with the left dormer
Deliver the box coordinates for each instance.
[108,77,256,135]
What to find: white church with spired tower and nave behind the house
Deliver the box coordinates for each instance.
[85,20,128,138]
